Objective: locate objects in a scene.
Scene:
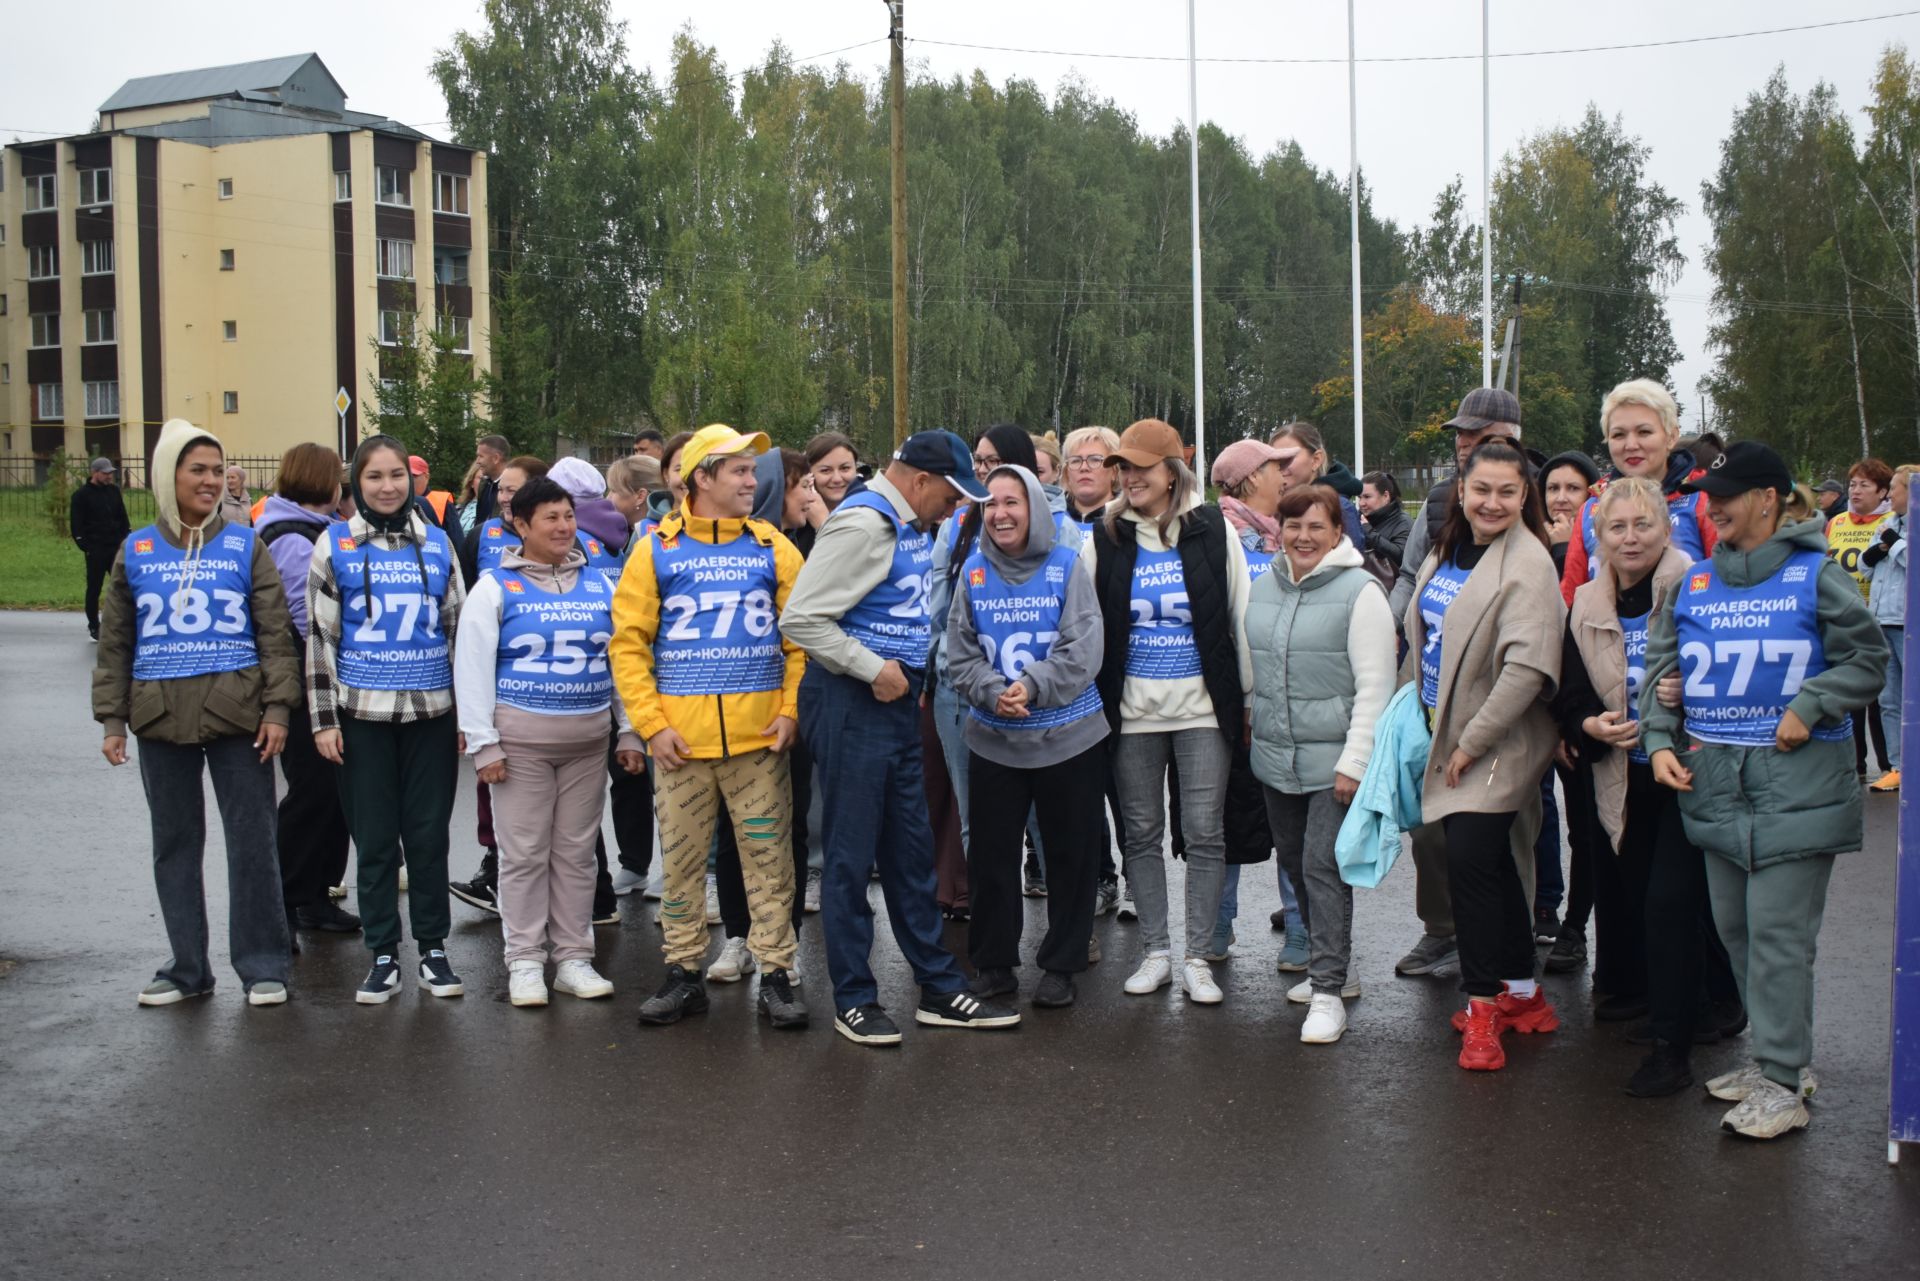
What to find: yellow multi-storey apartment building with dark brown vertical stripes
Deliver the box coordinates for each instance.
[0,54,490,470]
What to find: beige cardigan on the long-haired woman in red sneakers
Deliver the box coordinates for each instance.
[1400,524,1567,822]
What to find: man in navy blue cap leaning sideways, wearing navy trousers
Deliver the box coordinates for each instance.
[780,432,1020,1045]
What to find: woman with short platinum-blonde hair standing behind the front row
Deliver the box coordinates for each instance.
[1561,378,1716,605]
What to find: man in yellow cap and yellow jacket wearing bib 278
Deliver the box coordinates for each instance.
[609,424,806,1027]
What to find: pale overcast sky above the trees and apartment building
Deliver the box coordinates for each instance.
[0,0,1920,435]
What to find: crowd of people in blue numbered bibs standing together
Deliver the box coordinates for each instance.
[86,380,1889,1139]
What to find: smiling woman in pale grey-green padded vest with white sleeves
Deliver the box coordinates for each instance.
[1246,484,1398,1045]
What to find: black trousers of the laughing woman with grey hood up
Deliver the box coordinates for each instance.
[966,741,1106,974]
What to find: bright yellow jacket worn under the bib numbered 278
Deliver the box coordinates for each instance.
[607,503,806,761]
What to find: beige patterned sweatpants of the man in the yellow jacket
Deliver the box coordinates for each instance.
[653,749,795,970]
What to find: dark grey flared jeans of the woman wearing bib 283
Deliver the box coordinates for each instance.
[136,736,290,993]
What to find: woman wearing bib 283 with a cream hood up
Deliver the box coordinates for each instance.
[94,419,300,1004]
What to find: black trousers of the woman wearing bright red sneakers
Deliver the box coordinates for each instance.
[1440,810,1534,997]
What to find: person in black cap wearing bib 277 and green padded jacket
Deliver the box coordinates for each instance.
[1640,440,1887,1139]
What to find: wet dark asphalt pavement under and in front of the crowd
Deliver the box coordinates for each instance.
[0,615,1920,1281]
